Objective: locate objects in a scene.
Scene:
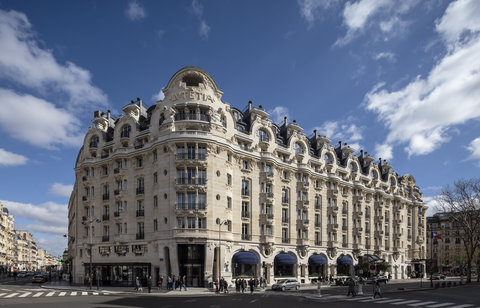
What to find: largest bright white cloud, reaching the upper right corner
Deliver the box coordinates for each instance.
[365,1,480,156]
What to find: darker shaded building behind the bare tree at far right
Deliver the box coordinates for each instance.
[427,213,476,275]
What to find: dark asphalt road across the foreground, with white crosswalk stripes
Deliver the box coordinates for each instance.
[0,281,480,308]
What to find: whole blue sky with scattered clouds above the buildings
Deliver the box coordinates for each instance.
[0,0,480,254]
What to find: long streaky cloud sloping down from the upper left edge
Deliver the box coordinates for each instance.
[0,10,107,111]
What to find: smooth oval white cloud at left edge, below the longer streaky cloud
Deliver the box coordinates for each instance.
[0,89,84,149]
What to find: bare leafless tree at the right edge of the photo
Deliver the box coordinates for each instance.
[437,178,480,282]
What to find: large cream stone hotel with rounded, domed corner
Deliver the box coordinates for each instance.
[68,67,427,286]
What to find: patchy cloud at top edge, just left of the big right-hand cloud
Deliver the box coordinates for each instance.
[334,0,418,46]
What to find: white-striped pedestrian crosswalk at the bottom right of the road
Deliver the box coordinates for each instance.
[306,294,480,308]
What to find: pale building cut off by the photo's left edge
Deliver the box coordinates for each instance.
[0,202,15,273]
